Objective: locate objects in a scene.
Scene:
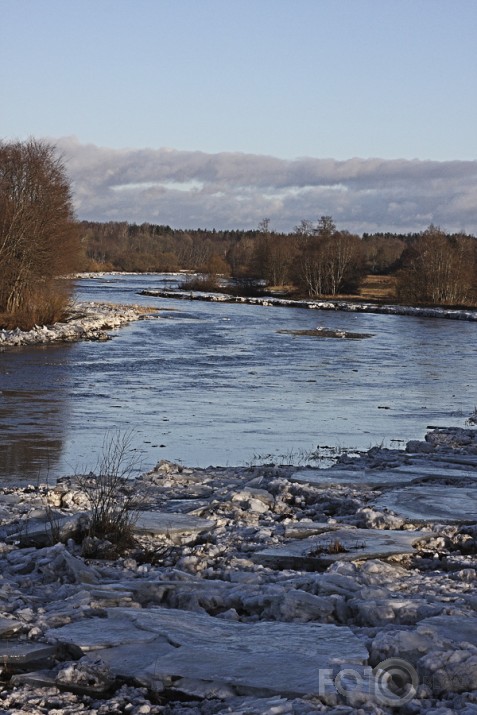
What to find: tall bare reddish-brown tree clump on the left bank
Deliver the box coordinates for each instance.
[0,139,80,328]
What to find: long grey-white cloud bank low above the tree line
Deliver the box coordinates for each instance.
[55,137,477,234]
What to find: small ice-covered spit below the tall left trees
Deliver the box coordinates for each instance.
[0,303,150,351]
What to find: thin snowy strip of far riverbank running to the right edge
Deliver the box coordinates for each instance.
[141,290,477,321]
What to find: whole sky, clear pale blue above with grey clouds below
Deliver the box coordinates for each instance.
[0,0,477,235]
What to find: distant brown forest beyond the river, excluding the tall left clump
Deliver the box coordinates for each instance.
[80,216,477,306]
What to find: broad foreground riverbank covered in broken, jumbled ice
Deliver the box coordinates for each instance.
[0,428,477,715]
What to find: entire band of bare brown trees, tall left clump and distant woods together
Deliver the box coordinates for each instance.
[0,139,477,327]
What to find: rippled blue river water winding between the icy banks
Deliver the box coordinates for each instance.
[0,275,477,482]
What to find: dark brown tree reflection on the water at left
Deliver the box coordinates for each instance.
[0,345,71,484]
